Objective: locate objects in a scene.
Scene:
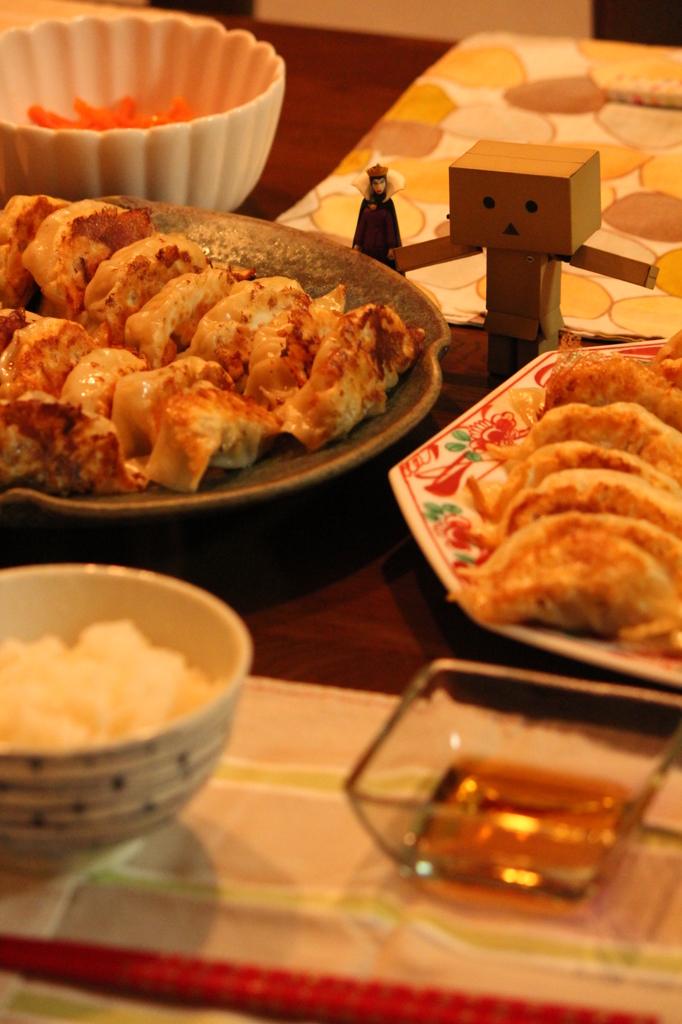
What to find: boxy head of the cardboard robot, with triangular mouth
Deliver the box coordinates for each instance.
[450,142,601,256]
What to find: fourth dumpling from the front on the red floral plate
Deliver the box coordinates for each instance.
[487,401,682,484]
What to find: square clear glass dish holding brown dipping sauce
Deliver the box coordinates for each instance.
[346,659,682,902]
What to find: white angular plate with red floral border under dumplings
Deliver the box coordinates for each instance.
[389,341,682,688]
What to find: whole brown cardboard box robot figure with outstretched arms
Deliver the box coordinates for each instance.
[394,142,658,377]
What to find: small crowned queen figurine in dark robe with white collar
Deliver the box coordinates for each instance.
[353,164,404,269]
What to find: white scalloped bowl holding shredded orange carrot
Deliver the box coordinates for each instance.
[0,13,285,210]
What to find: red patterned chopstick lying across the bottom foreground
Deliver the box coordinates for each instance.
[0,936,657,1024]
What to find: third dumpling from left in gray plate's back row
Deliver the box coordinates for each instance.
[84,234,209,348]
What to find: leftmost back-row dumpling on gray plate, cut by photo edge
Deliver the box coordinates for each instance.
[0,196,69,308]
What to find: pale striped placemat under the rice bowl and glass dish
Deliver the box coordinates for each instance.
[0,679,682,1024]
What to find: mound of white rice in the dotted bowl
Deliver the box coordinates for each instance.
[0,621,224,750]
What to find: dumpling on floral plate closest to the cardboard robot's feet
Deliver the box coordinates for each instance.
[545,351,682,430]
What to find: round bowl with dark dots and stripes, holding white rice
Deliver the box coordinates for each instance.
[0,564,252,860]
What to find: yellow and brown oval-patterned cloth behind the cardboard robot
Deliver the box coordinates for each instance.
[281,33,682,338]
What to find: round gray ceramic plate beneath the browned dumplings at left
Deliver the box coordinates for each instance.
[0,198,451,524]
